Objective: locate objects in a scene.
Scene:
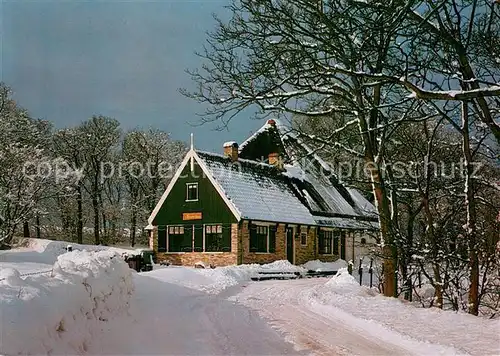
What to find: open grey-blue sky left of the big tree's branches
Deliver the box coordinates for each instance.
[0,0,264,152]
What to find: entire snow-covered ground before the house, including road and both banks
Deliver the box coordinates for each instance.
[0,241,500,355]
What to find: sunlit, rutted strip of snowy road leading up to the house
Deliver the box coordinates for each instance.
[230,278,418,355]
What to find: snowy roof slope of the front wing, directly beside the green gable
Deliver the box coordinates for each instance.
[197,151,315,225]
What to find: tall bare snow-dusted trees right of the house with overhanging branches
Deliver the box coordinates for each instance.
[185,0,500,315]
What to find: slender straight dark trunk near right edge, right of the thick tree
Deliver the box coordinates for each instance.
[462,101,479,315]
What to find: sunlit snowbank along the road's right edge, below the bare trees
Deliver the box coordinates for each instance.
[303,269,500,355]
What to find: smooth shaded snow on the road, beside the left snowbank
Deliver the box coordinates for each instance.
[89,274,303,355]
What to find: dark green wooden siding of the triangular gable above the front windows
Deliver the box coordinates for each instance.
[153,162,237,225]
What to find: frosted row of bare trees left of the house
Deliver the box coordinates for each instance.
[0,83,186,246]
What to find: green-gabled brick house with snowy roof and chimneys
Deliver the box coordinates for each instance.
[149,120,378,266]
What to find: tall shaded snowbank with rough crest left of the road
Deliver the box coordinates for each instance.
[0,251,134,355]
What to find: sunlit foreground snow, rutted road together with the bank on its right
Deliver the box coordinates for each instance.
[230,270,500,355]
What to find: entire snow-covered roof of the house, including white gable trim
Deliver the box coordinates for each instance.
[148,120,378,230]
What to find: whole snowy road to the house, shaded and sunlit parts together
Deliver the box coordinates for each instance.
[98,274,454,356]
